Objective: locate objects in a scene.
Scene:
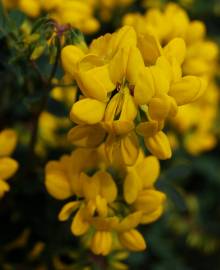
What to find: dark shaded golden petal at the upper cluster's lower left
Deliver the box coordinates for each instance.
[67,124,106,147]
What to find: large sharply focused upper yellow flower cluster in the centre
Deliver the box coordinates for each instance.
[61,26,206,165]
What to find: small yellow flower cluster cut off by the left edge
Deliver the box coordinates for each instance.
[0,129,18,198]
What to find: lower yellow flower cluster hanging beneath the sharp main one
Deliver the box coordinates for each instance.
[45,145,165,255]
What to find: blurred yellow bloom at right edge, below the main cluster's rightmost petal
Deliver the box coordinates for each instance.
[171,83,219,155]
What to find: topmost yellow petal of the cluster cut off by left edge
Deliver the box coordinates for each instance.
[0,129,17,157]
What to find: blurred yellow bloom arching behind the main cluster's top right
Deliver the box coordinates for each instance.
[124,3,218,77]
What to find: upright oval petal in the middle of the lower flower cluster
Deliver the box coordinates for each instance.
[95,171,117,203]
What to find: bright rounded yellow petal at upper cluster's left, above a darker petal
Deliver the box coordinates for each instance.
[70,98,106,125]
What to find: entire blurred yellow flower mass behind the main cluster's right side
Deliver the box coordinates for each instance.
[124,3,219,154]
